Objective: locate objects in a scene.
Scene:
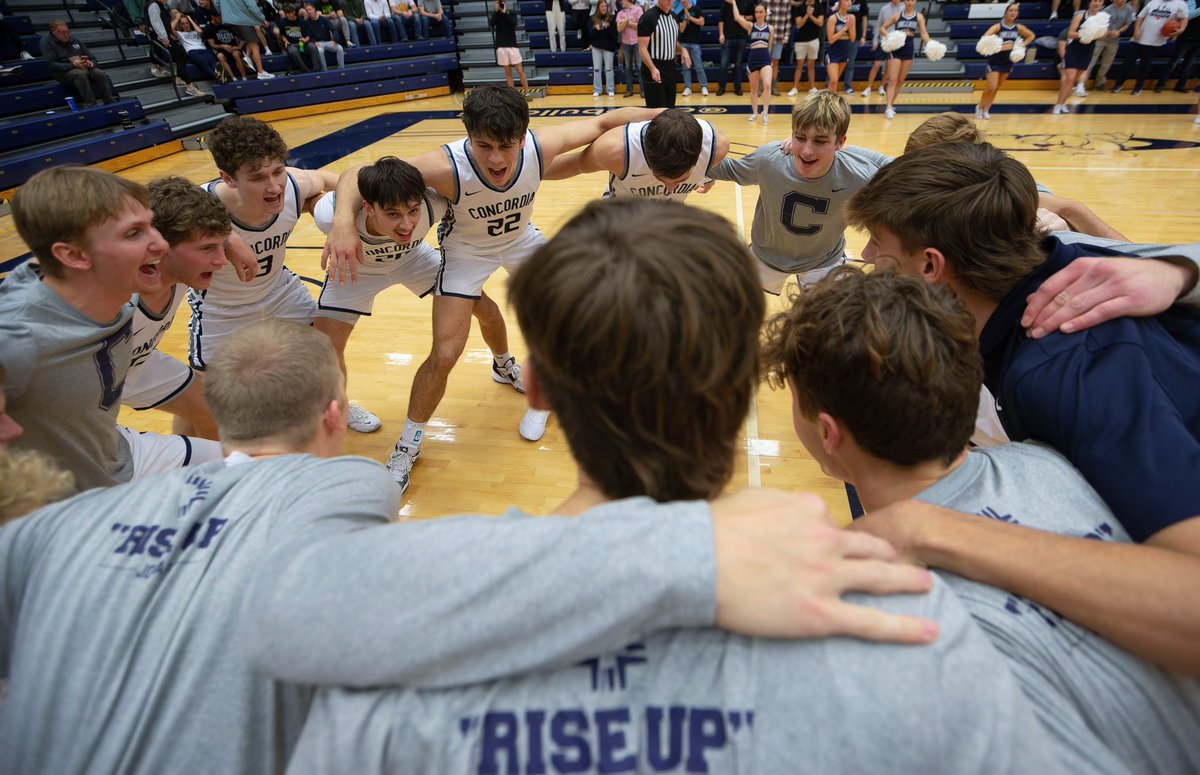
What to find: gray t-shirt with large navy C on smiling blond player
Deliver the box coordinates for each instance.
[709,143,892,274]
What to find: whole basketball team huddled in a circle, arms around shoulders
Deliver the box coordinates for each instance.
[0,86,1200,775]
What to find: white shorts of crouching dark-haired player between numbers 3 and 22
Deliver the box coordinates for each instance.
[317,242,442,325]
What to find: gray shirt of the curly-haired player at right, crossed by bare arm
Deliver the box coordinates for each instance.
[917,444,1200,774]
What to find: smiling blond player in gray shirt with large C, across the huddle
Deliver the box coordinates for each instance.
[710,90,892,295]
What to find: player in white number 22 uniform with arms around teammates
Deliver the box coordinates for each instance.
[322,85,656,489]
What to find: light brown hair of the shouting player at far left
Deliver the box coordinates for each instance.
[12,167,150,277]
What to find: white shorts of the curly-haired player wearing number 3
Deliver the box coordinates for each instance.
[187,269,317,372]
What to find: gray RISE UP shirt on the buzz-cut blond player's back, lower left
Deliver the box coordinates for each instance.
[0,455,400,775]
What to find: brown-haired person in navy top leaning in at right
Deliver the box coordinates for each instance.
[847,143,1200,675]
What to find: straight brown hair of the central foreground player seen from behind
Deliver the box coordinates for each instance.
[509,198,766,501]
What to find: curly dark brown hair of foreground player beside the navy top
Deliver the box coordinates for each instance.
[762,266,983,465]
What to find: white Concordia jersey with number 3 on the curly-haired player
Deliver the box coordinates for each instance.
[200,173,301,307]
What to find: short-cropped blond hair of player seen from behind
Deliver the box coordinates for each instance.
[204,319,346,451]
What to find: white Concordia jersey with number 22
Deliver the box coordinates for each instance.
[438,131,542,256]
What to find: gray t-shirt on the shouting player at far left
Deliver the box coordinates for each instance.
[0,262,133,489]
